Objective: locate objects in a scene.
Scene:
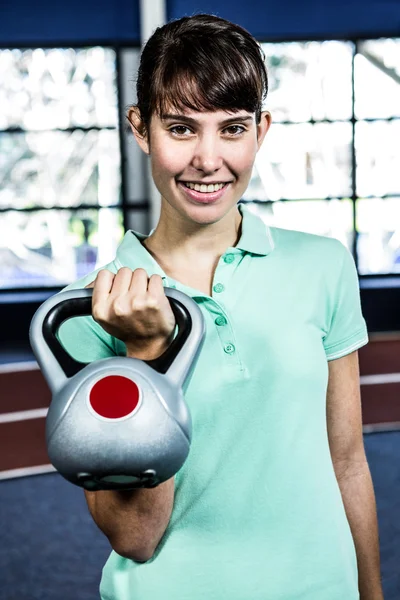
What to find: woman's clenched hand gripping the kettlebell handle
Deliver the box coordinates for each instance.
[86,267,176,358]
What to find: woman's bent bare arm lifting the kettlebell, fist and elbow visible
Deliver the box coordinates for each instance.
[77,268,175,562]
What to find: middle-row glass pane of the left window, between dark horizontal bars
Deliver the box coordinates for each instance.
[0,130,121,208]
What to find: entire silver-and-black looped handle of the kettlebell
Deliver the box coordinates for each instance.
[29,287,205,393]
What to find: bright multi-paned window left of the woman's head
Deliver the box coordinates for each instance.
[0,47,123,289]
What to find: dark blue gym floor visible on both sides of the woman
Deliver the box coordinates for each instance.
[0,432,400,600]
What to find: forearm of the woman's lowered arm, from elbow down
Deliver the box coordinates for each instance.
[334,463,383,600]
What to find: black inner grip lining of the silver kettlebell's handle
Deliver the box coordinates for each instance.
[43,289,192,377]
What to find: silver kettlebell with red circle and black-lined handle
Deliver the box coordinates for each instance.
[29,287,205,491]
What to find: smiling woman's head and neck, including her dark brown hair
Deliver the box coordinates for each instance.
[123,15,271,253]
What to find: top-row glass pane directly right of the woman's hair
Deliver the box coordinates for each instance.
[262,41,353,121]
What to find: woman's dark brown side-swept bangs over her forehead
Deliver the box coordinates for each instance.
[150,41,264,116]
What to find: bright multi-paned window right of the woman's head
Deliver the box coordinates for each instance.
[244,39,400,276]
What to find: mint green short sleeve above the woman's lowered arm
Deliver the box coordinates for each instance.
[323,243,368,361]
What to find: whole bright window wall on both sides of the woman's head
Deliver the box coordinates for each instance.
[0,38,400,290]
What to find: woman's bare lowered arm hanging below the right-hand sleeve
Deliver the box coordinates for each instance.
[327,351,383,600]
